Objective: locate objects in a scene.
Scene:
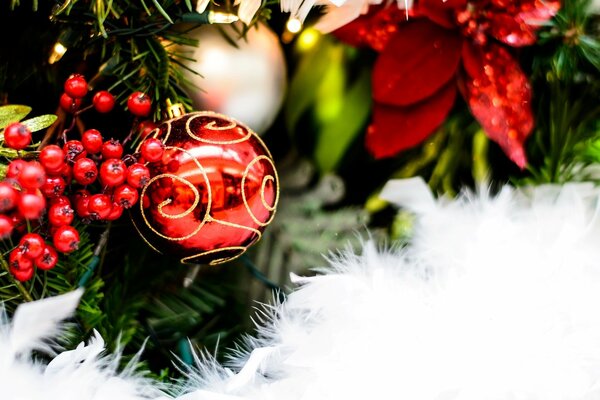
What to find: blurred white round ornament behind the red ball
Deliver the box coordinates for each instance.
[179,24,287,134]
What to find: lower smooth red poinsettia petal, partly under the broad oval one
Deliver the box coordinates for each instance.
[366,82,456,158]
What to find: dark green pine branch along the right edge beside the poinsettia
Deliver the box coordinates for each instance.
[526,0,600,183]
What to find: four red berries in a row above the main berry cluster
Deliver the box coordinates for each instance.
[59,74,152,117]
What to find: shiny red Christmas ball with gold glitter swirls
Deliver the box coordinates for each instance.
[132,112,279,265]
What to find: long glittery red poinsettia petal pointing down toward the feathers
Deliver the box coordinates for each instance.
[461,44,533,168]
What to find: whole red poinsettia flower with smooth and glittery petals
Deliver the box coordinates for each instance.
[336,0,560,168]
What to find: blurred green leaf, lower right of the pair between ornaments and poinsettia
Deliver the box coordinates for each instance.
[315,68,371,172]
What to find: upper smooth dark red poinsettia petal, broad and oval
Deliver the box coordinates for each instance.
[373,19,462,106]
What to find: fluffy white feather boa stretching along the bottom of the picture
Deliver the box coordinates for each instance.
[0,180,600,400]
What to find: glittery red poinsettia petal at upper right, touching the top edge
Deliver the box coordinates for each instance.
[489,0,560,47]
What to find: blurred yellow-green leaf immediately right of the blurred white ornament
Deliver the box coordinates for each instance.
[285,37,335,134]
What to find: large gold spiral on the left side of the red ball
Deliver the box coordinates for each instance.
[139,146,212,241]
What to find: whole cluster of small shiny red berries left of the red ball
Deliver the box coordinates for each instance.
[0,75,164,281]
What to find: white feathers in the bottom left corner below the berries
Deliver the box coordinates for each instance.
[0,290,167,400]
